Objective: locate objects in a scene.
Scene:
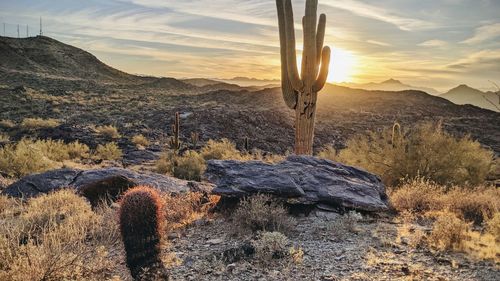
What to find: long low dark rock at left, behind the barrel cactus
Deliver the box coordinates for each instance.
[3,168,211,204]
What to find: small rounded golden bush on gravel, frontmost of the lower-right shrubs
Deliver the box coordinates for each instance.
[428,212,470,251]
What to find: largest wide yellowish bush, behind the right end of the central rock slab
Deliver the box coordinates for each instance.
[334,123,493,186]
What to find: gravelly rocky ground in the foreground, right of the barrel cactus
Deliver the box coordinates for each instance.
[163,212,500,281]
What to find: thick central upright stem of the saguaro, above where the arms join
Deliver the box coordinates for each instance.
[302,0,318,86]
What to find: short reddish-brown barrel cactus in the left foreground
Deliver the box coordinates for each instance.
[120,187,165,280]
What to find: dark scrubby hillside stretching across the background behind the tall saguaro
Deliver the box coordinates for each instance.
[0,37,500,153]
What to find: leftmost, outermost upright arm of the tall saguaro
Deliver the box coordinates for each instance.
[276,0,298,109]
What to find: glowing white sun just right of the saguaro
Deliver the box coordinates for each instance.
[327,48,358,83]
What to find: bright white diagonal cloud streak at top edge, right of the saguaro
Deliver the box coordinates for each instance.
[322,0,434,31]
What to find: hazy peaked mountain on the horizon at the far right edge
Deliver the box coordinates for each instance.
[441,85,500,112]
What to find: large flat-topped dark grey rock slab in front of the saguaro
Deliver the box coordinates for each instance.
[205,156,388,211]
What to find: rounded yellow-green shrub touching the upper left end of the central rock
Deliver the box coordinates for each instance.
[173,150,206,181]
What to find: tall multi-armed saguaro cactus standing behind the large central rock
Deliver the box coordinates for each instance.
[276,0,330,155]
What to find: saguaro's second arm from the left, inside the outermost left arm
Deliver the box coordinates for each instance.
[283,0,304,91]
